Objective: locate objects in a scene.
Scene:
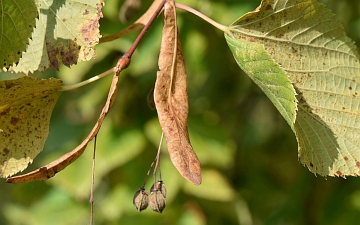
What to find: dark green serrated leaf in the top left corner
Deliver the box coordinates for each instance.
[0,0,38,71]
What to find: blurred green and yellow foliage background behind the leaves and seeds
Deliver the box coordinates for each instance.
[0,0,360,225]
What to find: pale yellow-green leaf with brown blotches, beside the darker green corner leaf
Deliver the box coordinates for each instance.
[9,0,103,73]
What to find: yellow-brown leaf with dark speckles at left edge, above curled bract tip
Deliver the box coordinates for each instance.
[0,76,62,177]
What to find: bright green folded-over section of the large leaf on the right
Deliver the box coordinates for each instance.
[225,34,296,129]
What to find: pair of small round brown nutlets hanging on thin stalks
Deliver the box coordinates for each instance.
[133,180,166,213]
